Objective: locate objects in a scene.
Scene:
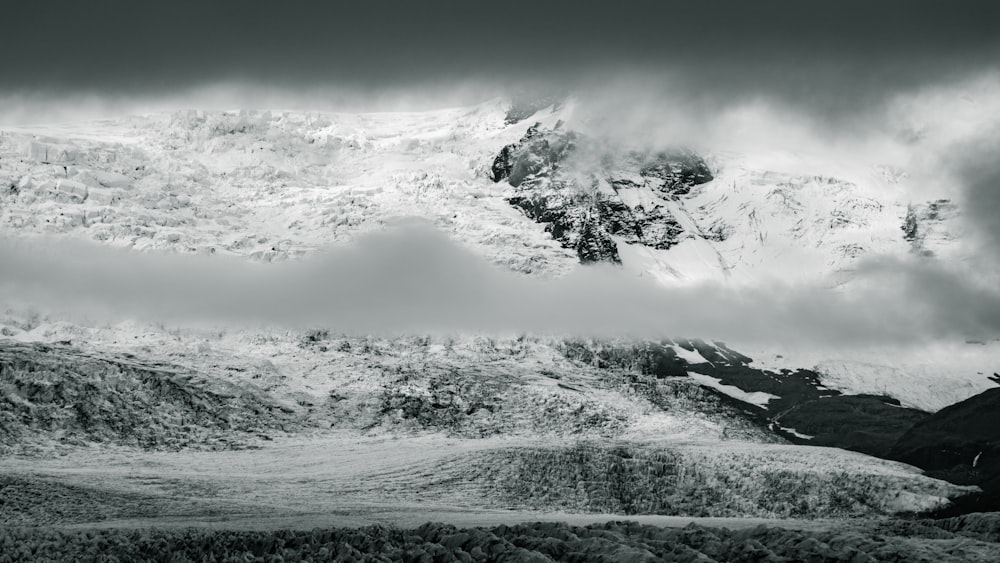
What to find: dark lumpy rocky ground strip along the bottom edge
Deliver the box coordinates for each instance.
[0,515,998,562]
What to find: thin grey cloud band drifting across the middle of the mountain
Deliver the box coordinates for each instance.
[0,224,1000,347]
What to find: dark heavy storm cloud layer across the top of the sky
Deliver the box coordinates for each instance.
[7,0,1000,111]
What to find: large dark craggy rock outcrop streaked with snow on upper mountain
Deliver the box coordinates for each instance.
[490,123,712,263]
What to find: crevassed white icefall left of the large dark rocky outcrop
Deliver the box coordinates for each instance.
[0,101,574,273]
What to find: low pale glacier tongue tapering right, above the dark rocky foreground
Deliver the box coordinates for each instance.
[0,432,962,529]
